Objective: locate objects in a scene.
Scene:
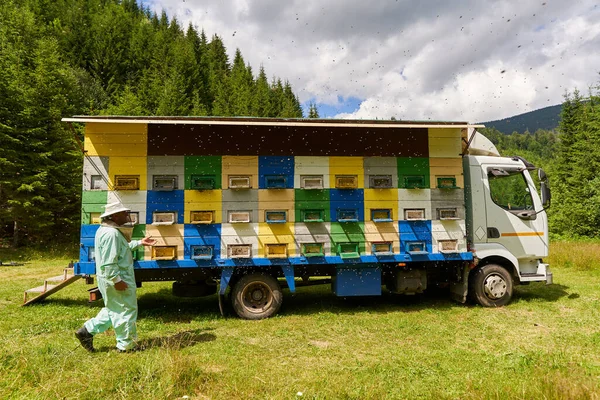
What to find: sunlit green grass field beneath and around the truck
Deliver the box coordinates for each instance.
[0,242,600,399]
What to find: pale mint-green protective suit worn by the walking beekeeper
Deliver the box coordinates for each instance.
[84,221,141,350]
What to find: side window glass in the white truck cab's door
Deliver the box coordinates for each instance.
[488,171,533,211]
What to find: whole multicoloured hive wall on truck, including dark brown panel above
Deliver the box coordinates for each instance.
[75,118,467,268]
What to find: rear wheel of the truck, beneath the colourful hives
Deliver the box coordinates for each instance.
[231,273,283,319]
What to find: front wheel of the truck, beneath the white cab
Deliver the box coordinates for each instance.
[469,264,513,307]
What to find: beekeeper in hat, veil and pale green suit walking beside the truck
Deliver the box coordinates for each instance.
[75,202,155,352]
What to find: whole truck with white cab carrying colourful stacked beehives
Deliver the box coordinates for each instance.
[58,116,552,319]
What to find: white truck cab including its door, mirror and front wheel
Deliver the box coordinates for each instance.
[463,132,552,306]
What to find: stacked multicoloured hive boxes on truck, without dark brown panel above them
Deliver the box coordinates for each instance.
[81,122,467,268]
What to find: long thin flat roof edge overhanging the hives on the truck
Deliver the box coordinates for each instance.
[62,115,484,128]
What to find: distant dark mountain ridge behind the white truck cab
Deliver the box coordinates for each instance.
[482,104,562,135]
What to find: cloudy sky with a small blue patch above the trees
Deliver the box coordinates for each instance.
[144,0,600,123]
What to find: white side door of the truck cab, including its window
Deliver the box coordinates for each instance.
[482,165,548,259]
